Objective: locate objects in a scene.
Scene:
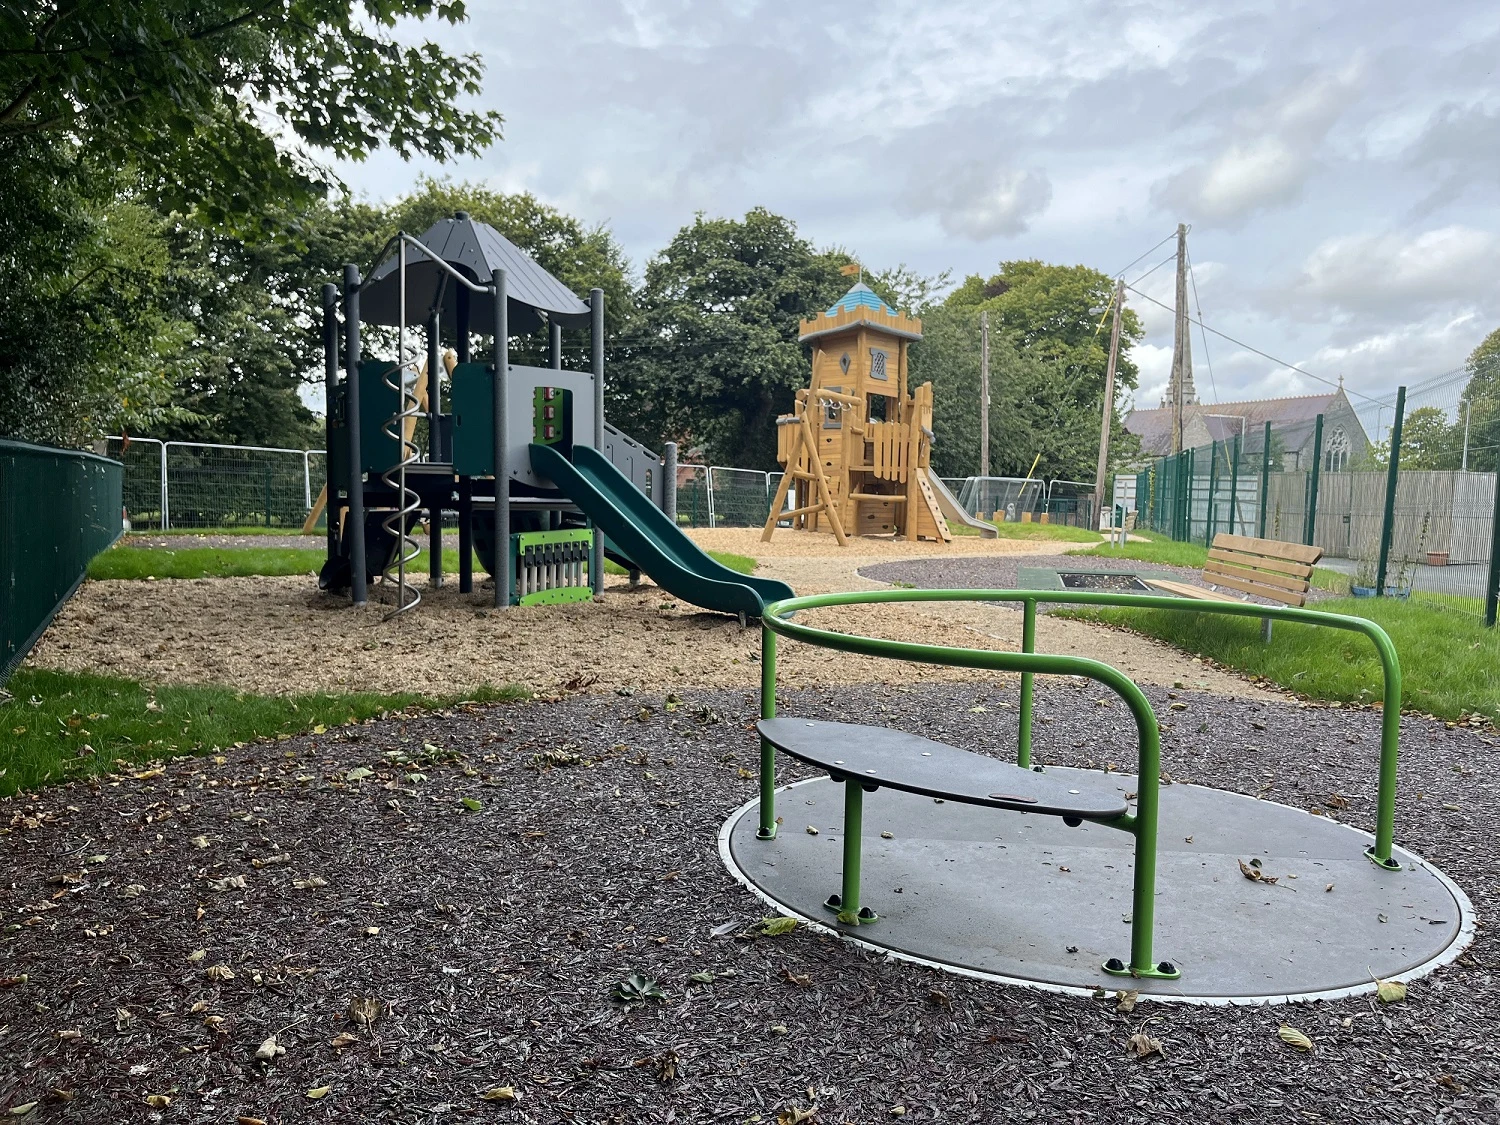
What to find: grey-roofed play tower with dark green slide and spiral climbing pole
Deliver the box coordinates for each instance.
[320,212,792,615]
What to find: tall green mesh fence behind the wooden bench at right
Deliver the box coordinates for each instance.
[1136,374,1500,626]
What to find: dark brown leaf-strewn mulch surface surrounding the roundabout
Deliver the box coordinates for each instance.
[0,681,1500,1125]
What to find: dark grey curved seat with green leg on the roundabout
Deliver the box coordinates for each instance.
[756,719,1181,980]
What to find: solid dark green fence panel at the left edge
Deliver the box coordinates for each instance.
[0,441,125,684]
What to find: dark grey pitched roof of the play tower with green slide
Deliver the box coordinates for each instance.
[360,212,590,339]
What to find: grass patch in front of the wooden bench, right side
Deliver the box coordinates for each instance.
[1067,599,1500,722]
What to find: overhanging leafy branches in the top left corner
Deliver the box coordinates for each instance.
[0,0,501,234]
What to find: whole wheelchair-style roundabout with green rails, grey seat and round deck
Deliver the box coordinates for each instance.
[720,590,1475,1004]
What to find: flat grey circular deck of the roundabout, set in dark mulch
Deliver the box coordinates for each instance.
[720,767,1473,1004]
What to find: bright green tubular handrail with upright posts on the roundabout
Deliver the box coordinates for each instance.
[759,590,1401,977]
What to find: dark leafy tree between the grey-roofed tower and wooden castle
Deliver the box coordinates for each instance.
[611,207,849,470]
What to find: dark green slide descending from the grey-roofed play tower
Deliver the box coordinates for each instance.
[531,446,795,617]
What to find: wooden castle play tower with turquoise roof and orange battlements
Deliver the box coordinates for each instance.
[761,282,996,546]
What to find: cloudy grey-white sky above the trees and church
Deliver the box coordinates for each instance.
[341,0,1500,435]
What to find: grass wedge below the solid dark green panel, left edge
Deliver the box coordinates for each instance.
[0,668,531,795]
